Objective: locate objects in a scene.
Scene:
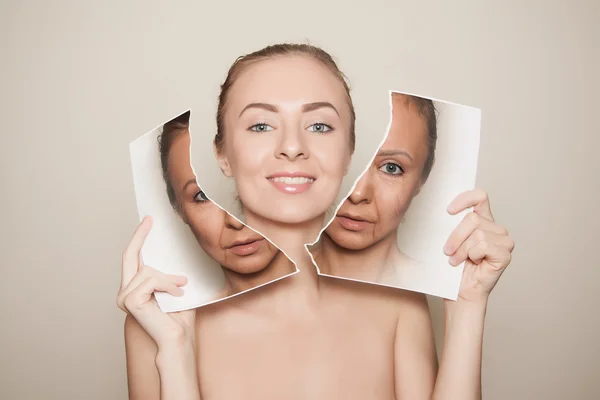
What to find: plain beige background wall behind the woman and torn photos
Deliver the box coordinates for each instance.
[0,0,600,400]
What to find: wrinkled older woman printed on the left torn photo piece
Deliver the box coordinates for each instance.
[159,111,296,299]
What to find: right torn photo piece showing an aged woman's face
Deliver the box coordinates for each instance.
[309,92,480,299]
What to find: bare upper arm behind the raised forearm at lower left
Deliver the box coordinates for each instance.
[125,315,160,400]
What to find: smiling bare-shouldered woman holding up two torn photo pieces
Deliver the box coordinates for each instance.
[119,45,512,400]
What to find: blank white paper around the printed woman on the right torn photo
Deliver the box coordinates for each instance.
[317,90,481,300]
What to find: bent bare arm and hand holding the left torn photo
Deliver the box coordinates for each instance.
[117,218,200,400]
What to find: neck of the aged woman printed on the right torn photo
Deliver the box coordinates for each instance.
[311,232,400,282]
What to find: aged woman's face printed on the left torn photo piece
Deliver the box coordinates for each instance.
[168,132,279,274]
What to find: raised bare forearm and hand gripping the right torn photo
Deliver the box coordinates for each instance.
[433,190,514,400]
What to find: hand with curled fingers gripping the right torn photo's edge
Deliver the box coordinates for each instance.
[444,189,515,302]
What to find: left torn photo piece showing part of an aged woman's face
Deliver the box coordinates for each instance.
[130,111,297,312]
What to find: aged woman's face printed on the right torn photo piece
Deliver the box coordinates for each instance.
[325,95,428,250]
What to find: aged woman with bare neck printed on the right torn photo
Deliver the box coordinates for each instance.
[311,93,437,287]
